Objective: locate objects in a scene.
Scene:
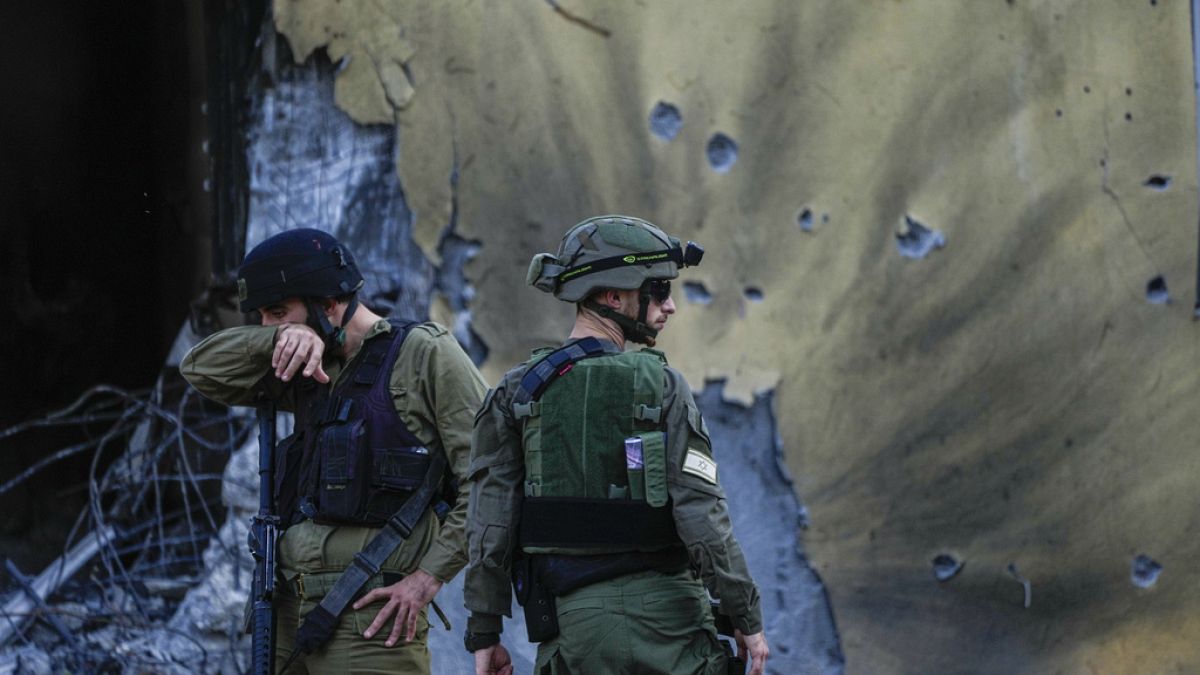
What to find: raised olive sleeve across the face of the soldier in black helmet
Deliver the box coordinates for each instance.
[179,325,280,406]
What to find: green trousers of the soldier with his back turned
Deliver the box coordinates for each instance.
[535,571,727,675]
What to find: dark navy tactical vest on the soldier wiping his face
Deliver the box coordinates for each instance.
[276,321,441,527]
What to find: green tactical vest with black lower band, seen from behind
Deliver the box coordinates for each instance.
[512,338,679,555]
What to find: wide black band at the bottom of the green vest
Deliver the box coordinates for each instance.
[518,497,679,550]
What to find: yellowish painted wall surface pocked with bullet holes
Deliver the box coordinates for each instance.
[275,0,1200,673]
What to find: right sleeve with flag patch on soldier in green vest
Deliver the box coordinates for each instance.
[664,370,762,635]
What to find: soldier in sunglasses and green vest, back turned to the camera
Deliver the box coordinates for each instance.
[464,216,768,675]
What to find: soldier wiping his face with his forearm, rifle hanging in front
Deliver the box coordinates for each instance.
[180,229,486,673]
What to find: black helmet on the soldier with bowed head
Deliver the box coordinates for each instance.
[238,228,362,312]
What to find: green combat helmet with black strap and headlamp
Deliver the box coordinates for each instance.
[526,215,704,345]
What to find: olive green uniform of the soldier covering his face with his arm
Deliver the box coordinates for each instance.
[180,321,487,673]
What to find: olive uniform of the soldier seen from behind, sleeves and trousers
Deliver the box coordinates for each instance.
[463,338,762,674]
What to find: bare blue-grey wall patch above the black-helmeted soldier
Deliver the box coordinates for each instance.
[246,44,433,318]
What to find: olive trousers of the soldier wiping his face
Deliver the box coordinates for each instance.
[275,520,432,675]
